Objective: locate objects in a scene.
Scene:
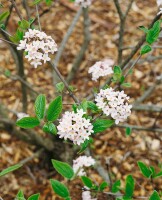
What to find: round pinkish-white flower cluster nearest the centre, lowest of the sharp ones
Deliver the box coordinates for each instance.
[57,109,94,145]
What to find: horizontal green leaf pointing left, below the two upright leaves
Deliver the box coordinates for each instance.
[16,117,40,128]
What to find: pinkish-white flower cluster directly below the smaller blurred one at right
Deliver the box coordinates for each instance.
[95,88,132,124]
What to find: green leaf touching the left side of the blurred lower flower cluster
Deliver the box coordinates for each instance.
[52,160,74,179]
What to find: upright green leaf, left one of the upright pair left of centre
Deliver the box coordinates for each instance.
[34,94,46,119]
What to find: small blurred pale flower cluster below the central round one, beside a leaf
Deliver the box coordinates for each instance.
[73,156,95,176]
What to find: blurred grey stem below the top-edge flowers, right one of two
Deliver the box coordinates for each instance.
[67,8,90,83]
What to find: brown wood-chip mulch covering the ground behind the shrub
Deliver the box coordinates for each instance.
[0,0,162,200]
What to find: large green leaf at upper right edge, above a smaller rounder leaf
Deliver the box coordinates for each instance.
[146,20,160,44]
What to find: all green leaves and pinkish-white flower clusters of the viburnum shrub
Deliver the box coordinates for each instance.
[0,0,162,200]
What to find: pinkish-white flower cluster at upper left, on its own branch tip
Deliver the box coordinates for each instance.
[17,29,57,68]
